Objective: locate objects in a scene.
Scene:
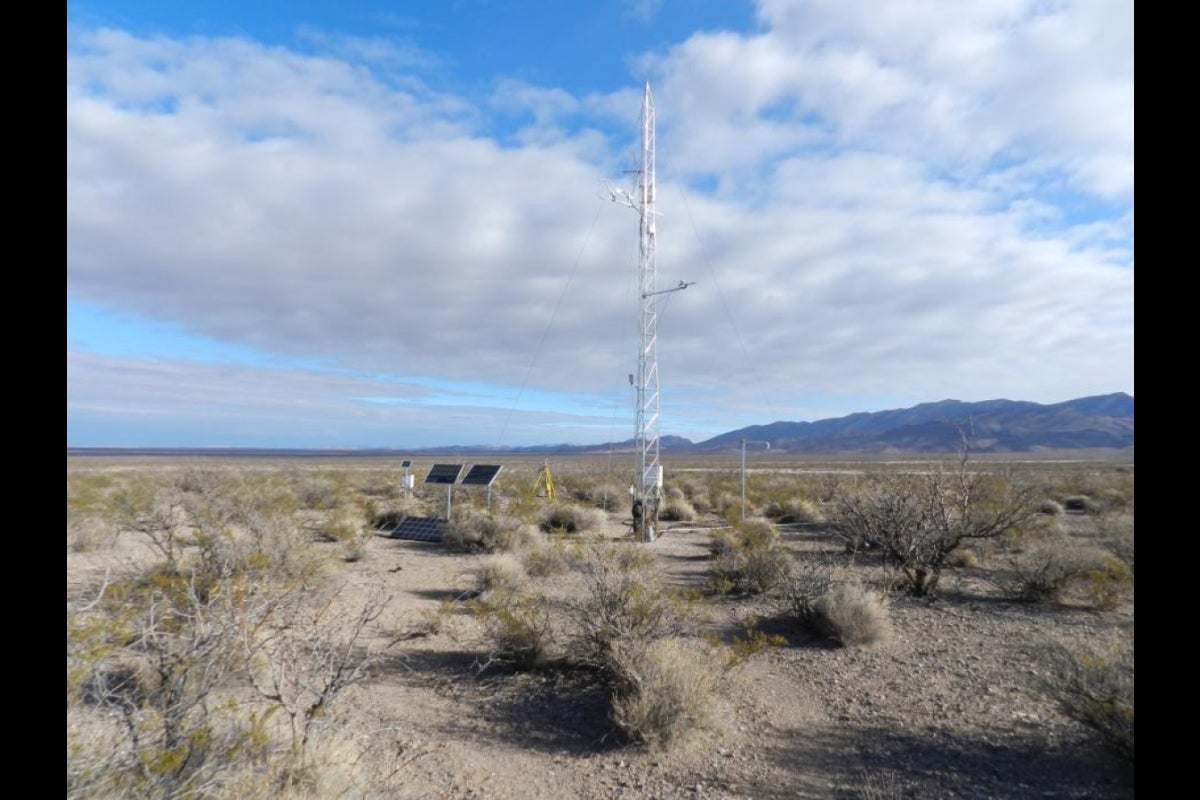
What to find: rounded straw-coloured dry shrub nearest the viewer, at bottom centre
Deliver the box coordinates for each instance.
[611,638,718,748]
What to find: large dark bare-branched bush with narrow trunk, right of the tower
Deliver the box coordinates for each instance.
[829,451,1037,596]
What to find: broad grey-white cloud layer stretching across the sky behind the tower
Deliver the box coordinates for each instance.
[67,1,1133,441]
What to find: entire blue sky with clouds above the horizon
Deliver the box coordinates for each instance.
[67,0,1134,449]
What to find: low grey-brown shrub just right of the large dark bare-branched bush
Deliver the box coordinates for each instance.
[992,534,1100,603]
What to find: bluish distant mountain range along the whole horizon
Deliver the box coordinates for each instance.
[67,392,1133,456]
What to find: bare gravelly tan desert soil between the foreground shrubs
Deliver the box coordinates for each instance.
[68,491,1133,800]
